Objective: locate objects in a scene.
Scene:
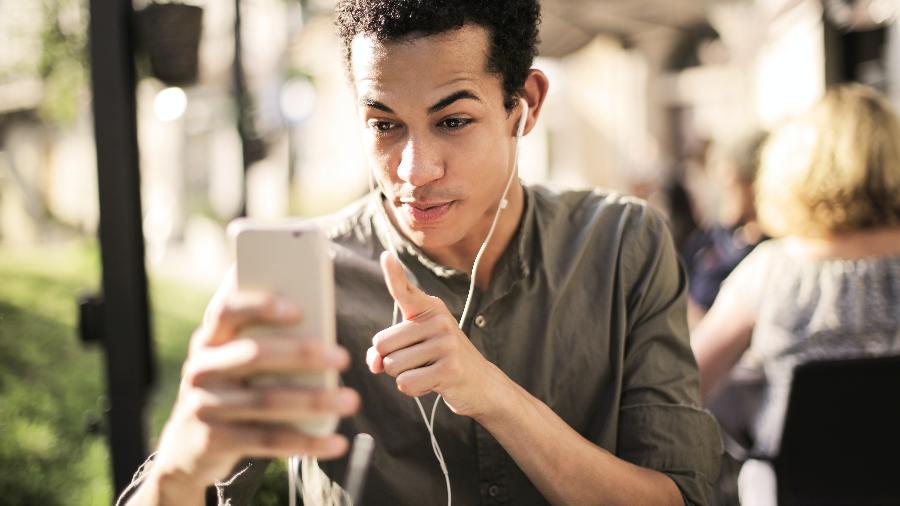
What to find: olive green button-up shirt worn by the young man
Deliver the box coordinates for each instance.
[121,187,722,506]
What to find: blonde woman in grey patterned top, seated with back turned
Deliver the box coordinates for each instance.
[692,85,900,505]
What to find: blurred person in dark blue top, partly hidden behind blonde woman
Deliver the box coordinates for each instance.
[682,132,766,328]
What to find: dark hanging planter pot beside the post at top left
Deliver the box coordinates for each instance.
[137,2,203,86]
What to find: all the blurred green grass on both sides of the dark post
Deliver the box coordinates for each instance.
[0,243,287,506]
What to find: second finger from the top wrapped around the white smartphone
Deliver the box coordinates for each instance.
[185,336,350,385]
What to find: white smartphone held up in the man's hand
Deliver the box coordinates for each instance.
[228,218,338,436]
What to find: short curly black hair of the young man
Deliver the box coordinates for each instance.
[335,0,541,110]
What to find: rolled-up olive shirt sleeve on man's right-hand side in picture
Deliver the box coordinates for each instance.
[617,204,722,505]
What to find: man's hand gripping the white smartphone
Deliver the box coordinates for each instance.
[133,274,359,504]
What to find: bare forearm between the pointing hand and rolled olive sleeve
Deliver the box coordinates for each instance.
[476,370,683,505]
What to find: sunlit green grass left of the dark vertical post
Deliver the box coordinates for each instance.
[0,243,110,505]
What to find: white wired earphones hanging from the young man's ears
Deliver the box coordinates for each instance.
[288,98,529,506]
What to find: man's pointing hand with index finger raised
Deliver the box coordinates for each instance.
[366,252,509,419]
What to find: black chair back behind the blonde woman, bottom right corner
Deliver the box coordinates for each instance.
[773,356,900,506]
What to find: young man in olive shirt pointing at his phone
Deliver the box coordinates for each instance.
[123,0,721,505]
